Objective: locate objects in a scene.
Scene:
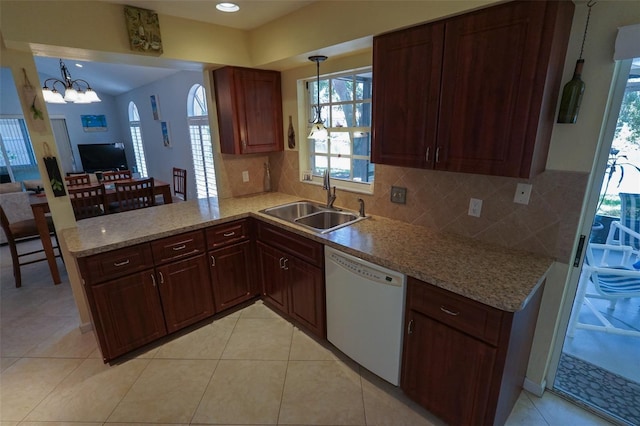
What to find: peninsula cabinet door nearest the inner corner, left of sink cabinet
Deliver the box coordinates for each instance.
[209,241,258,312]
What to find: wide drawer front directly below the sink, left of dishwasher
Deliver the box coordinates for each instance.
[258,222,324,267]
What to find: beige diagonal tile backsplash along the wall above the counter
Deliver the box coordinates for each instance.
[268,151,588,263]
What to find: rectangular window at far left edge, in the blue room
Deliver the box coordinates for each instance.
[0,118,40,182]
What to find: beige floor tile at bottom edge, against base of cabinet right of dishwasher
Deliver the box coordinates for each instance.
[361,368,445,426]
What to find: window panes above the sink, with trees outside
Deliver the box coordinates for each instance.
[306,68,374,188]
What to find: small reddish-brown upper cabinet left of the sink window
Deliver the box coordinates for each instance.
[213,67,283,154]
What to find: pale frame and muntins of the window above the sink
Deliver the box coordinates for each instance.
[298,66,375,194]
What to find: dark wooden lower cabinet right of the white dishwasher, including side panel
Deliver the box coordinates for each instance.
[401,277,542,425]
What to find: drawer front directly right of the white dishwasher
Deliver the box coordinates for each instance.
[407,277,503,346]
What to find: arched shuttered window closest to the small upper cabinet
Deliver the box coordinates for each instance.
[187,84,218,198]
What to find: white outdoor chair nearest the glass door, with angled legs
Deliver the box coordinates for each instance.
[567,243,640,337]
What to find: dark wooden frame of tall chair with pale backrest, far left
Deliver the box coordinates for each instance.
[0,193,62,287]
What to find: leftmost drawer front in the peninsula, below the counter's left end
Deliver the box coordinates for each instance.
[80,244,153,284]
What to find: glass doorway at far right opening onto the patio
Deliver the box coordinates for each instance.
[553,58,640,424]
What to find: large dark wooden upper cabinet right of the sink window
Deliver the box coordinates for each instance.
[372,1,574,178]
